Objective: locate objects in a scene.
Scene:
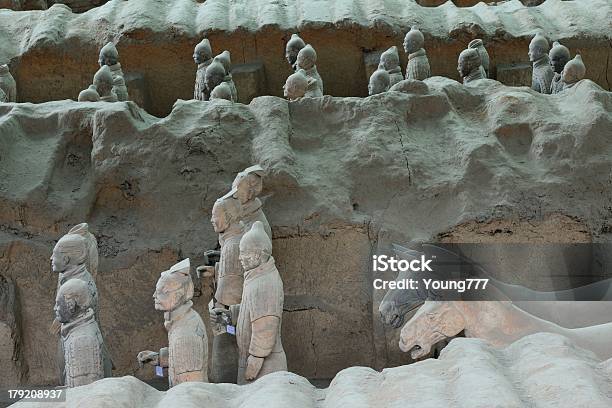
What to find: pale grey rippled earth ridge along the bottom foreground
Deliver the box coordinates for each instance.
[12,333,612,408]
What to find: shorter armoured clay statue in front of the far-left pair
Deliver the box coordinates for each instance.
[54,279,105,387]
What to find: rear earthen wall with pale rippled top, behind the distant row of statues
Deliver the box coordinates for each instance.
[0,0,612,116]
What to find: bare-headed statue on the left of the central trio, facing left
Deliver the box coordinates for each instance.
[200,196,244,383]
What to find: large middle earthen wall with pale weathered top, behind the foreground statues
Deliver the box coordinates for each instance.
[0,77,612,384]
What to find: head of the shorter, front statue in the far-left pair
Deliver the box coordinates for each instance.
[54,279,92,324]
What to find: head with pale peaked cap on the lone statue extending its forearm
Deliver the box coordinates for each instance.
[153,258,193,312]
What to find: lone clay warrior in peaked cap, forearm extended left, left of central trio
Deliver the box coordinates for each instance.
[137,258,208,387]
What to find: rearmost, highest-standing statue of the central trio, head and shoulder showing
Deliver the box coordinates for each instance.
[228,164,272,239]
